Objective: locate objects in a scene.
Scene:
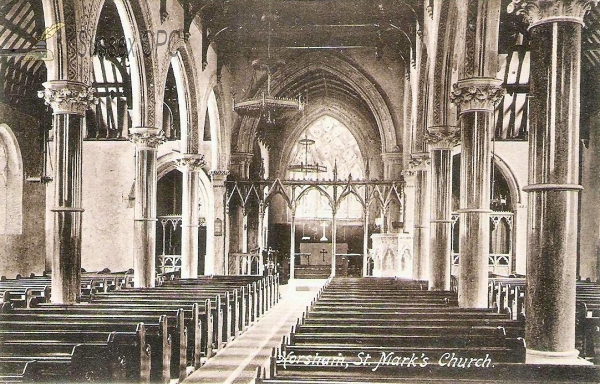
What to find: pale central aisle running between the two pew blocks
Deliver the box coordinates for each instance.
[183,279,325,384]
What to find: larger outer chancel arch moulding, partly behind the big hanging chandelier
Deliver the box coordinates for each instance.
[238,54,397,154]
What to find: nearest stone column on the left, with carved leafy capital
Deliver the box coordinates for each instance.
[38,80,97,304]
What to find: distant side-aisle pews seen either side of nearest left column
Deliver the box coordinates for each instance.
[0,269,133,308]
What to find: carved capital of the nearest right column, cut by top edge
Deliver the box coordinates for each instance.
[506,0,598,28]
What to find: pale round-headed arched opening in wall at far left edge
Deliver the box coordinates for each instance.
[0,124,23,235]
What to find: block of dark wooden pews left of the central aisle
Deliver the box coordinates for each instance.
[0,276,279,383]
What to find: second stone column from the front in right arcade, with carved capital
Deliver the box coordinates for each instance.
[450,77,504,308]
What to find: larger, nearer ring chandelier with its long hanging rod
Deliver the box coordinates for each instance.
[233,2,304,124]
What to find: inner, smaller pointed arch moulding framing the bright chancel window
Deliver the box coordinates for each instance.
[278,105,379,175]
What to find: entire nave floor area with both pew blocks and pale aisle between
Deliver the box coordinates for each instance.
[0,274,600,384]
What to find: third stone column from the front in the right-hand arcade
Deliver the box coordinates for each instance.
[425,126,460,291]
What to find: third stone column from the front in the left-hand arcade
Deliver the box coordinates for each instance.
[177,153,206,278]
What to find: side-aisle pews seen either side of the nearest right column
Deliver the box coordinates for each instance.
[488,277,600,364]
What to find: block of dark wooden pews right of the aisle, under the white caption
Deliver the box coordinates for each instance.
[256,278,600,384]
